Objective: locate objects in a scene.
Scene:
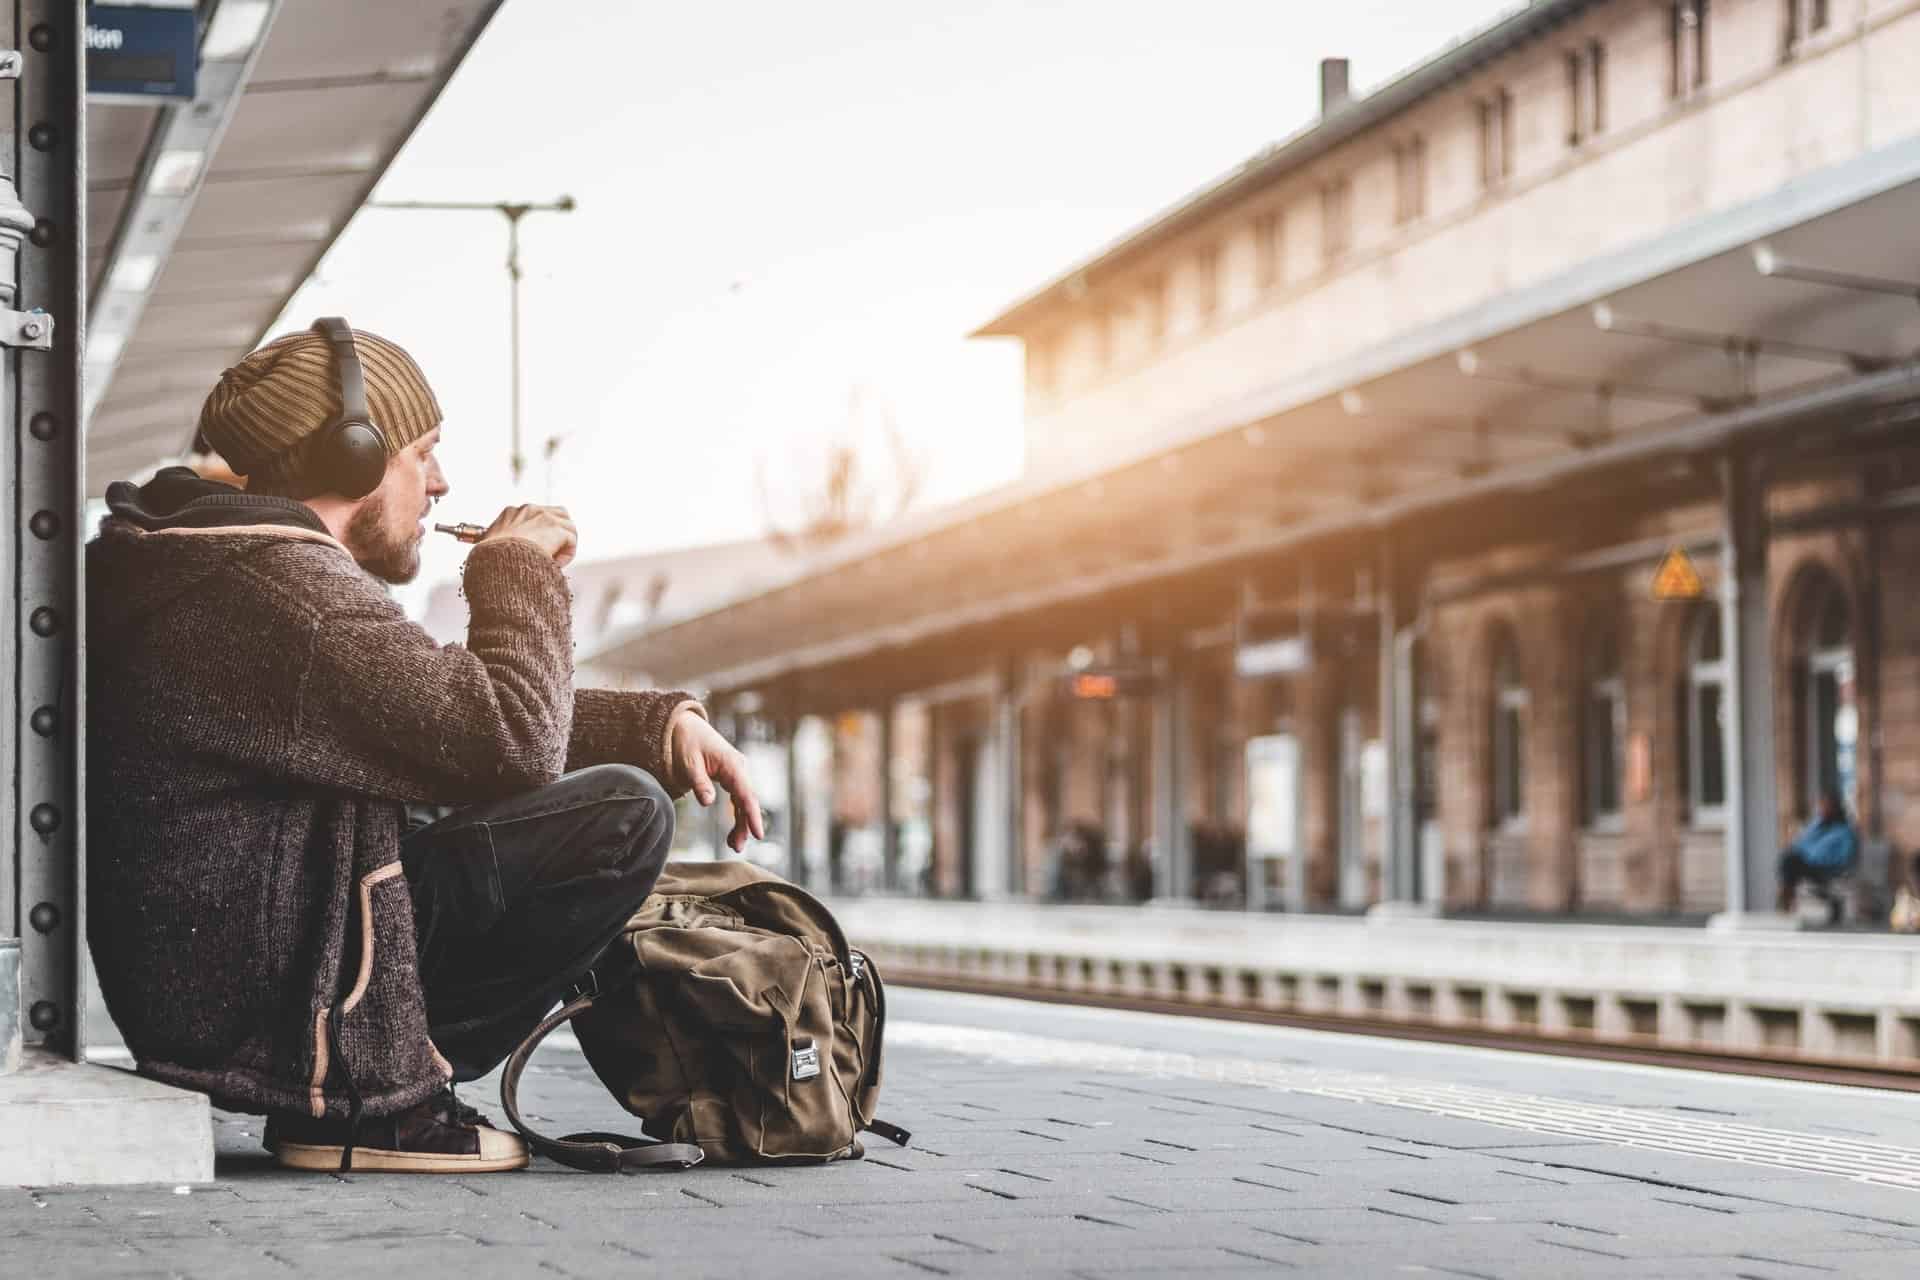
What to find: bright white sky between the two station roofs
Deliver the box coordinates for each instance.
[280,0,1513,601]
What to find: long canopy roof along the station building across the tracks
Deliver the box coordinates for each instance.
[589,155,1920,695]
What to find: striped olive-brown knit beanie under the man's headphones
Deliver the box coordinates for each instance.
[200,328,442,484]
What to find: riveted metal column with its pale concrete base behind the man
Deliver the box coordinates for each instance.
[0,0,213,1186]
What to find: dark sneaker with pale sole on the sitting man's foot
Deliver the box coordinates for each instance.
[267,1090,532,1173]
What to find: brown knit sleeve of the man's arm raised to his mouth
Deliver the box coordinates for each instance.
[276,539,574,804]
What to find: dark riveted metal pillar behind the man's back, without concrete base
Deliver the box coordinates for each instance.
[0,0,86,1059]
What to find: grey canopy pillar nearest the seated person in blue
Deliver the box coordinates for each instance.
[1720,455,1780,917]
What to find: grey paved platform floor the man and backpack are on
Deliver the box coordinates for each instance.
[11,988,1920,1280]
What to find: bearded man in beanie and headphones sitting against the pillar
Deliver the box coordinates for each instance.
[86,319,764,1174]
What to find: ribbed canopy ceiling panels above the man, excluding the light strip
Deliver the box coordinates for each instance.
[86,0,501,493]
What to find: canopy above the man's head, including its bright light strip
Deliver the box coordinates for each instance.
[86,0,501,495]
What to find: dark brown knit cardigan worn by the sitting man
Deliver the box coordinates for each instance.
[86,516,697,1115]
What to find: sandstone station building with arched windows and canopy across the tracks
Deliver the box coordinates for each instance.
[586,0,1920,919]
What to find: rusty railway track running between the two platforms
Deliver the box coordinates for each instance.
[889,969,1920,1094]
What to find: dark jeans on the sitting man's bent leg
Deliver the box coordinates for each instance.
[399,764,674,1080]
